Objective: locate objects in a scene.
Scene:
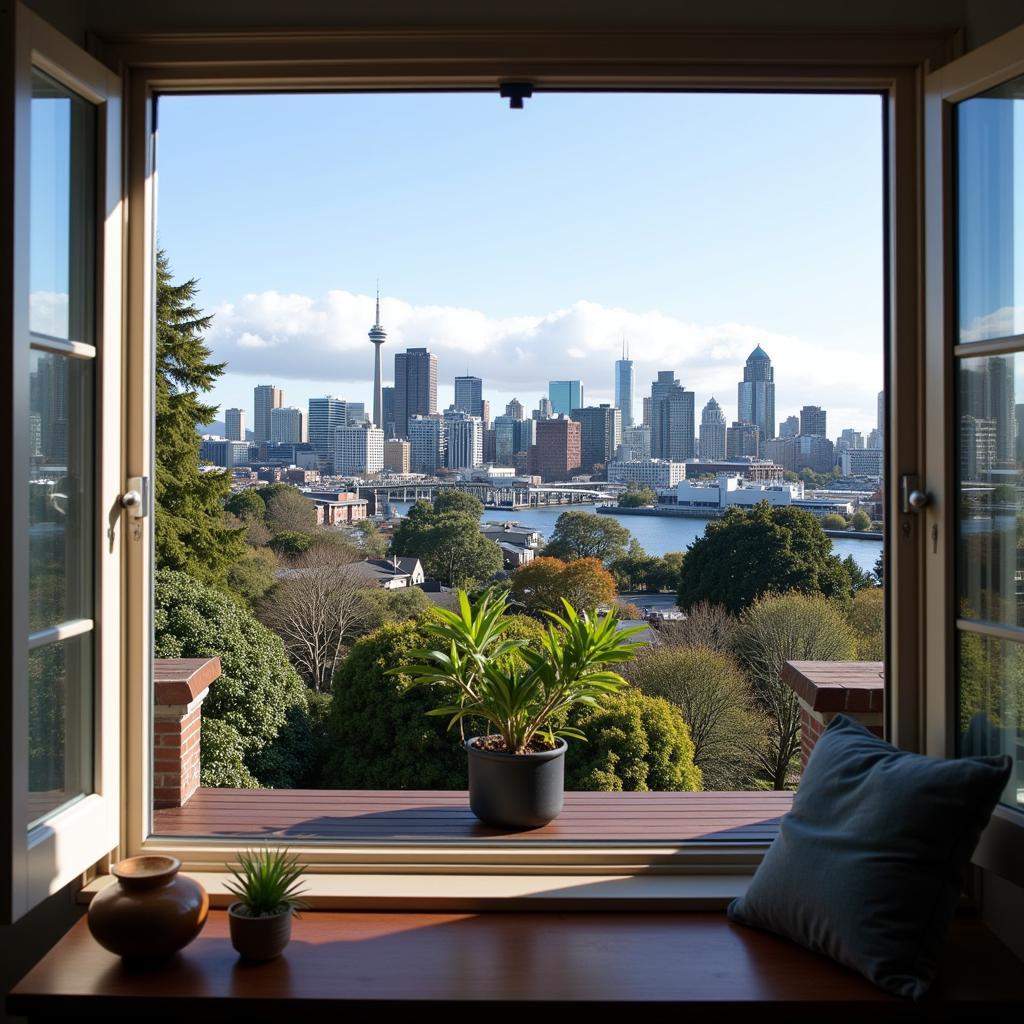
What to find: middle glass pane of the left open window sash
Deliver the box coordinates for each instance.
[29,352,93,632]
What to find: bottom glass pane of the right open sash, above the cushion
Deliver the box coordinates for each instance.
[957,632,1024,810]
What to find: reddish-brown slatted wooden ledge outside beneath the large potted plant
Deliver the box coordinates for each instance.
[154,790,793,843]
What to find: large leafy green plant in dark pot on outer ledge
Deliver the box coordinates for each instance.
[397,591,643,828]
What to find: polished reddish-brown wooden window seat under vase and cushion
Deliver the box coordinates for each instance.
[8,910,1024,1021]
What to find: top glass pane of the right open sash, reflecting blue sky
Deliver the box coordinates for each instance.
[956,78,1024,342]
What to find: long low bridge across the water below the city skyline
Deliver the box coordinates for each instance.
[358,480,625,515]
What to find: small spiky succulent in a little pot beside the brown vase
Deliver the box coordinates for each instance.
[226,849,305,961]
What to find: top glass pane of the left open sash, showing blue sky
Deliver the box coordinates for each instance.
[29,71,96,344]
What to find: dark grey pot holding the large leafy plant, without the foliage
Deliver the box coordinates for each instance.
[466,736,567,828]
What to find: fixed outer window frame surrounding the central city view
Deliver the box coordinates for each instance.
[94,30,937,874]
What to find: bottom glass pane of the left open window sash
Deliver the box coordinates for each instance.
[29,633,93,828]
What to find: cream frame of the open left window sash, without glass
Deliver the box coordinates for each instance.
[0,3,124,921]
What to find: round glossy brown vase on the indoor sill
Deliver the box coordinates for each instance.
[89,857,210,959]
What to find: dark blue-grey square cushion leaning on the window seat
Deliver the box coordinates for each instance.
[728,715,1011,999]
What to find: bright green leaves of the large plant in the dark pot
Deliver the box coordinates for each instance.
[389,591,643,754]
